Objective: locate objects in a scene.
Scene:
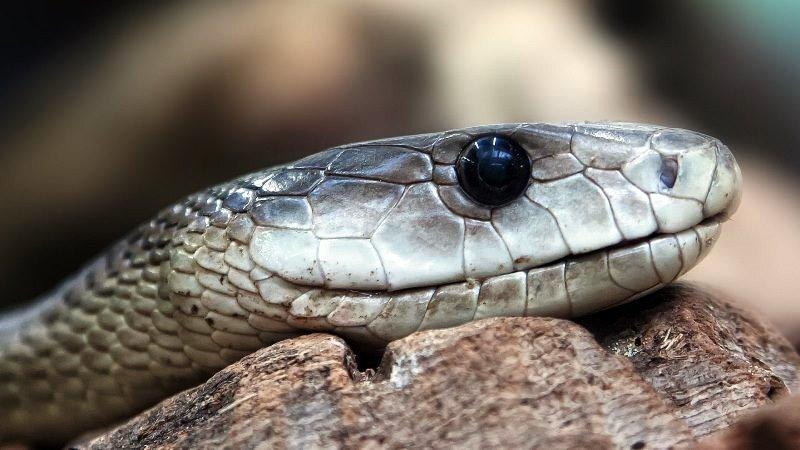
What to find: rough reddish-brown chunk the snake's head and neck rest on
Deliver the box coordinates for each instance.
[76,286,800,449]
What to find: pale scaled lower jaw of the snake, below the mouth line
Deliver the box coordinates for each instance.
[278,217,721,354]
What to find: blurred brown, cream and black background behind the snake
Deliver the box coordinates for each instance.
[0,0,800,344]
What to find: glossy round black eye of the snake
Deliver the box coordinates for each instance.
[456,136,531,206]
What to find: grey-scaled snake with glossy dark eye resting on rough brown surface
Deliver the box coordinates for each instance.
[0,122,741,443]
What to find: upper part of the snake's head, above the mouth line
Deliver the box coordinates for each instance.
[241,123,741,290]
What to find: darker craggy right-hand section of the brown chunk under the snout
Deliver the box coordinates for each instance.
[582,284,800,437]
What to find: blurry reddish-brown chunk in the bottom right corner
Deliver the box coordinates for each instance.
[700,396,800,450]
